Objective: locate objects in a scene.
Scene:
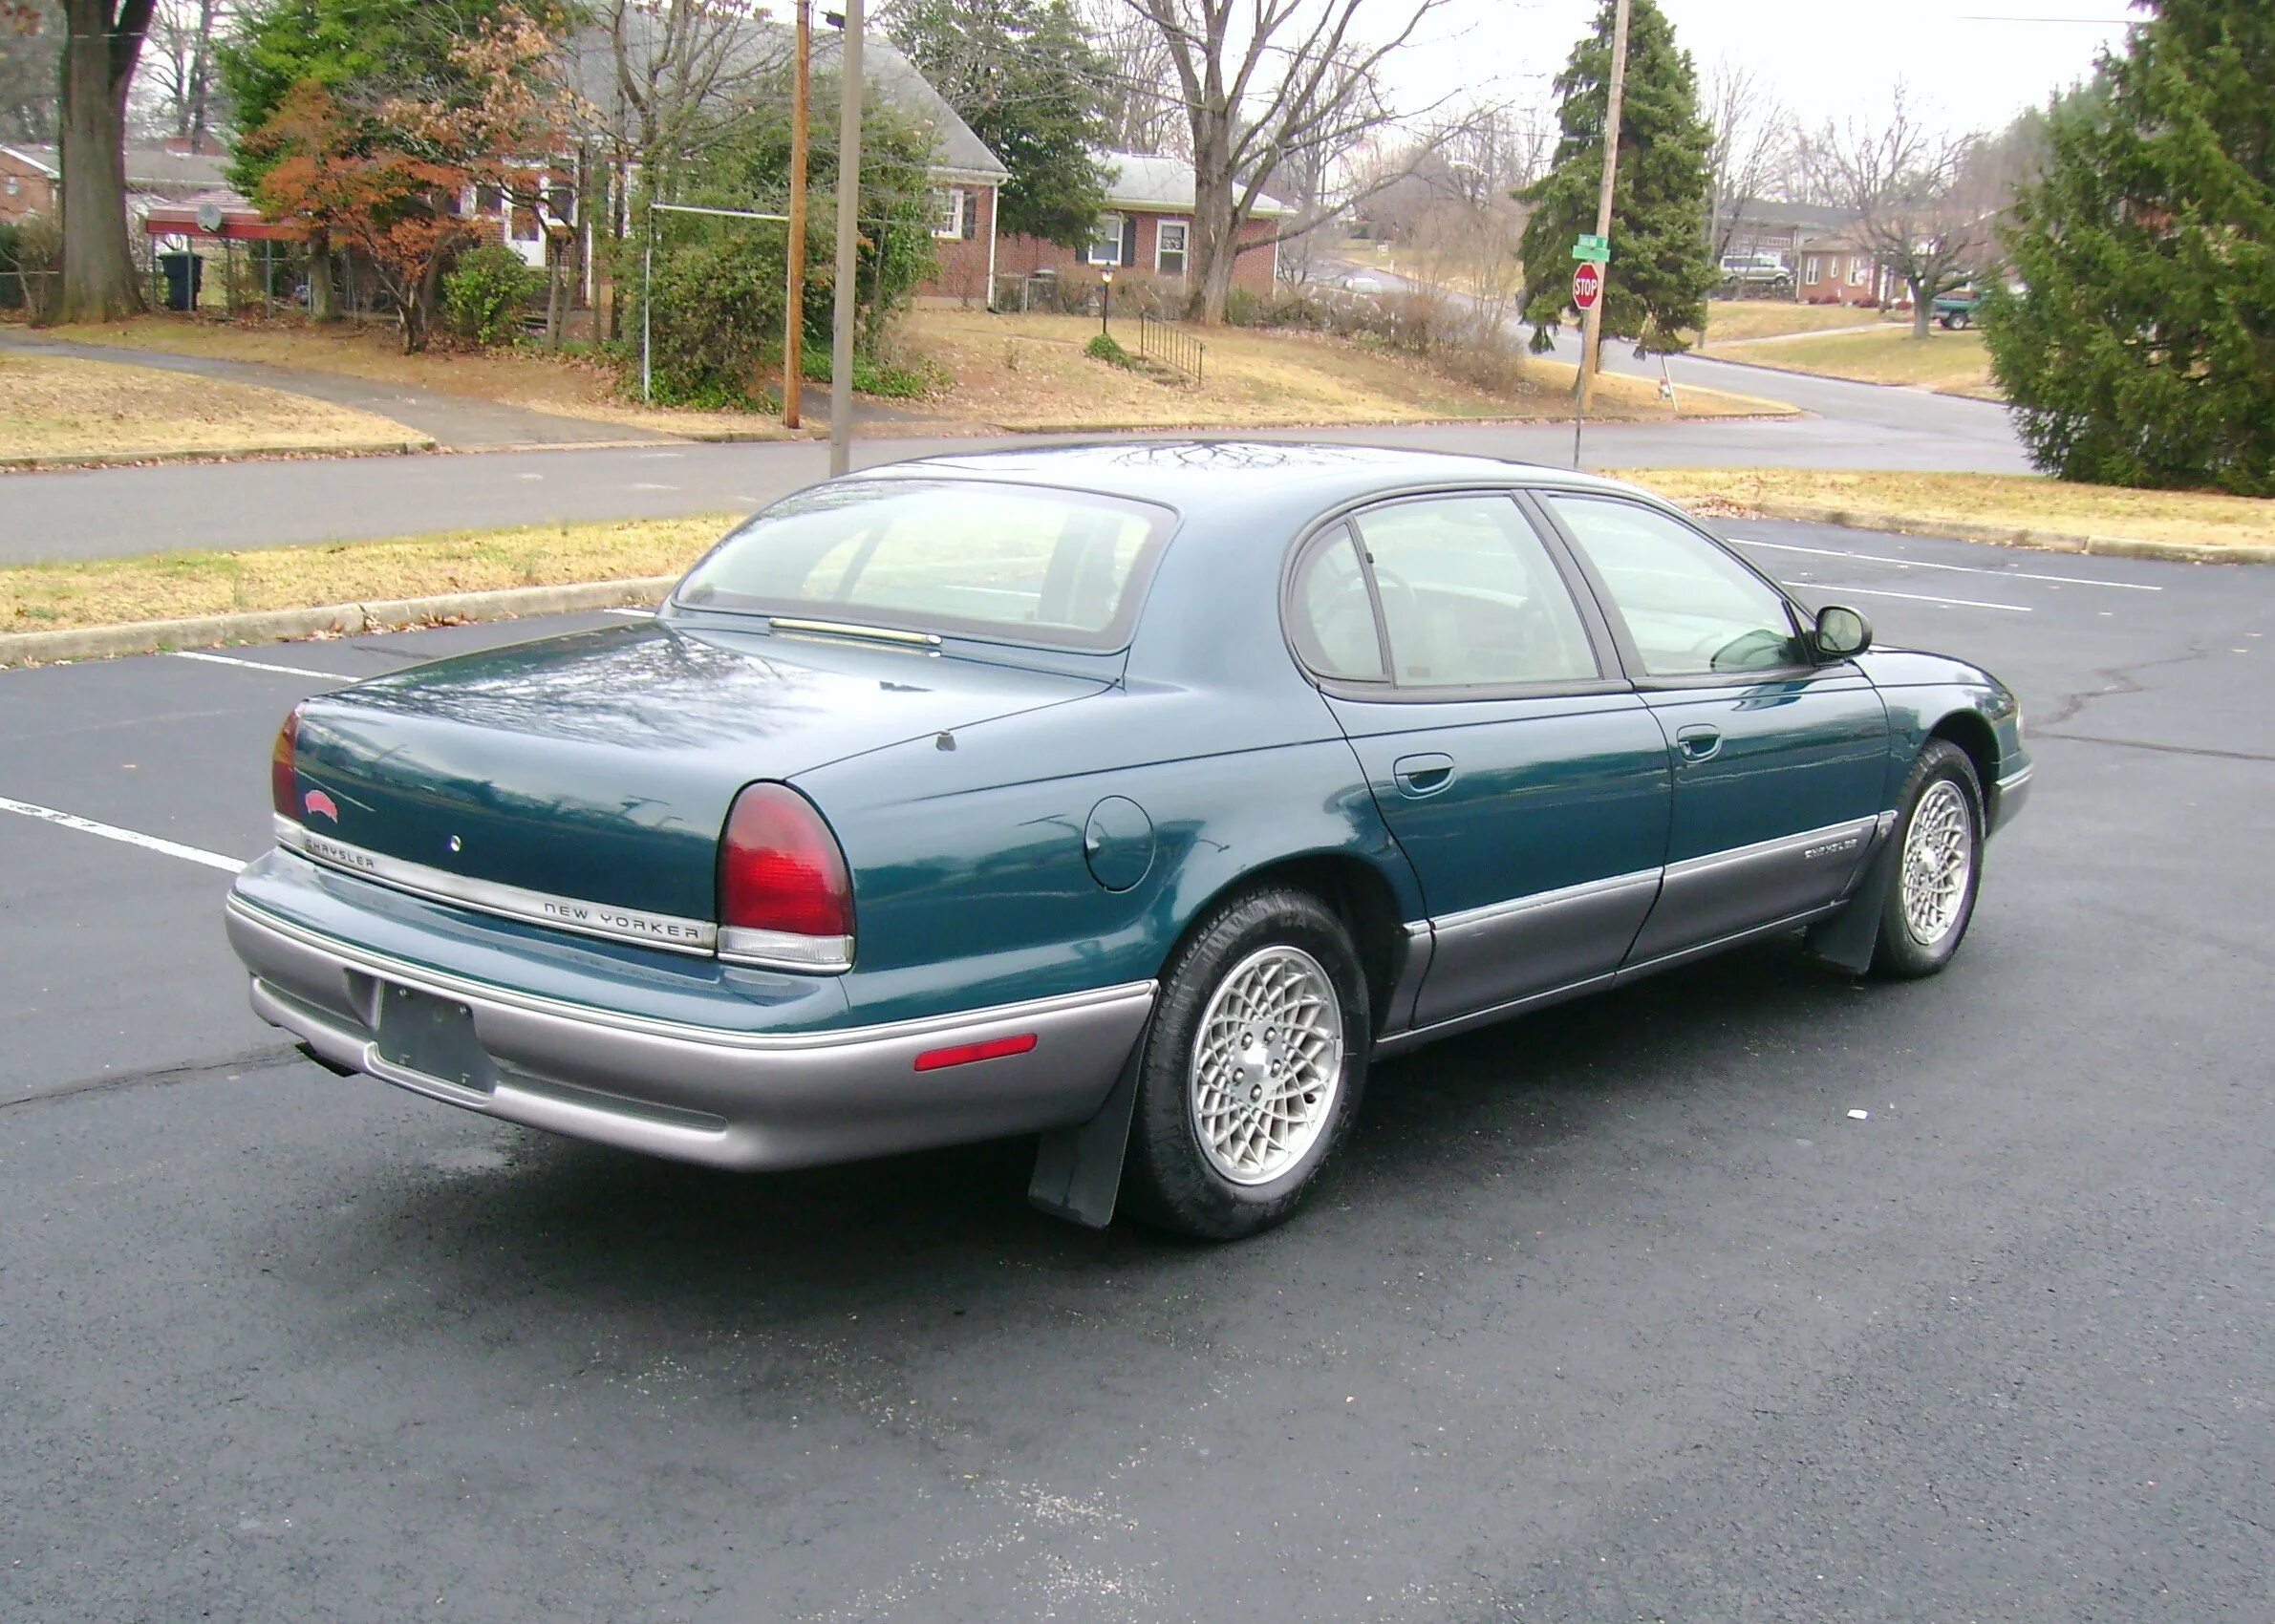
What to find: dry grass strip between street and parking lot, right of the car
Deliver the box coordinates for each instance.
[1618,468,2275,545]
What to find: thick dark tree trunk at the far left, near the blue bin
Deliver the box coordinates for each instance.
[50,0,150,321]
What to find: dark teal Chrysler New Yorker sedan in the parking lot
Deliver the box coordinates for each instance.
[227,441,2029,1237]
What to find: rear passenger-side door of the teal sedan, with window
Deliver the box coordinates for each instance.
[1288,491,1672,1026]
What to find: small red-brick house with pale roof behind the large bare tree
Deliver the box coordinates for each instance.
[964,153,1295,298]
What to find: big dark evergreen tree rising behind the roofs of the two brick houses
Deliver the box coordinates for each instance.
[890,0,1105,248]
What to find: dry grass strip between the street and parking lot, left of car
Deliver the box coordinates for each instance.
[0,514,740,632]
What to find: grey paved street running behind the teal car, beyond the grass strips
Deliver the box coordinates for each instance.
[0,397,2025,564]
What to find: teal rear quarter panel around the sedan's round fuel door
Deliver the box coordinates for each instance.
[794,493,1422,1021]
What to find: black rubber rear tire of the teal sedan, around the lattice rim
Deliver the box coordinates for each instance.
[1122,885,1374,1240]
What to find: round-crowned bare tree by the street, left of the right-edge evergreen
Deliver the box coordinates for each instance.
[1811,86,2002,339]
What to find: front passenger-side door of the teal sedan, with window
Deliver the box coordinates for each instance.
[1535,491,1888,965]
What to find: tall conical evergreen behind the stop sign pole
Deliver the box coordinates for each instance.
[1517,0,1715,354]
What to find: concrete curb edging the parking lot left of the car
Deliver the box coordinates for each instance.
[0,575,678,667]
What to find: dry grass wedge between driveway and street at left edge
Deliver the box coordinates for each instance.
[0,354,419,458]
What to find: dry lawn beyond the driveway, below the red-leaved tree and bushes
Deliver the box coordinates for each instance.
[53,316,787,437]
